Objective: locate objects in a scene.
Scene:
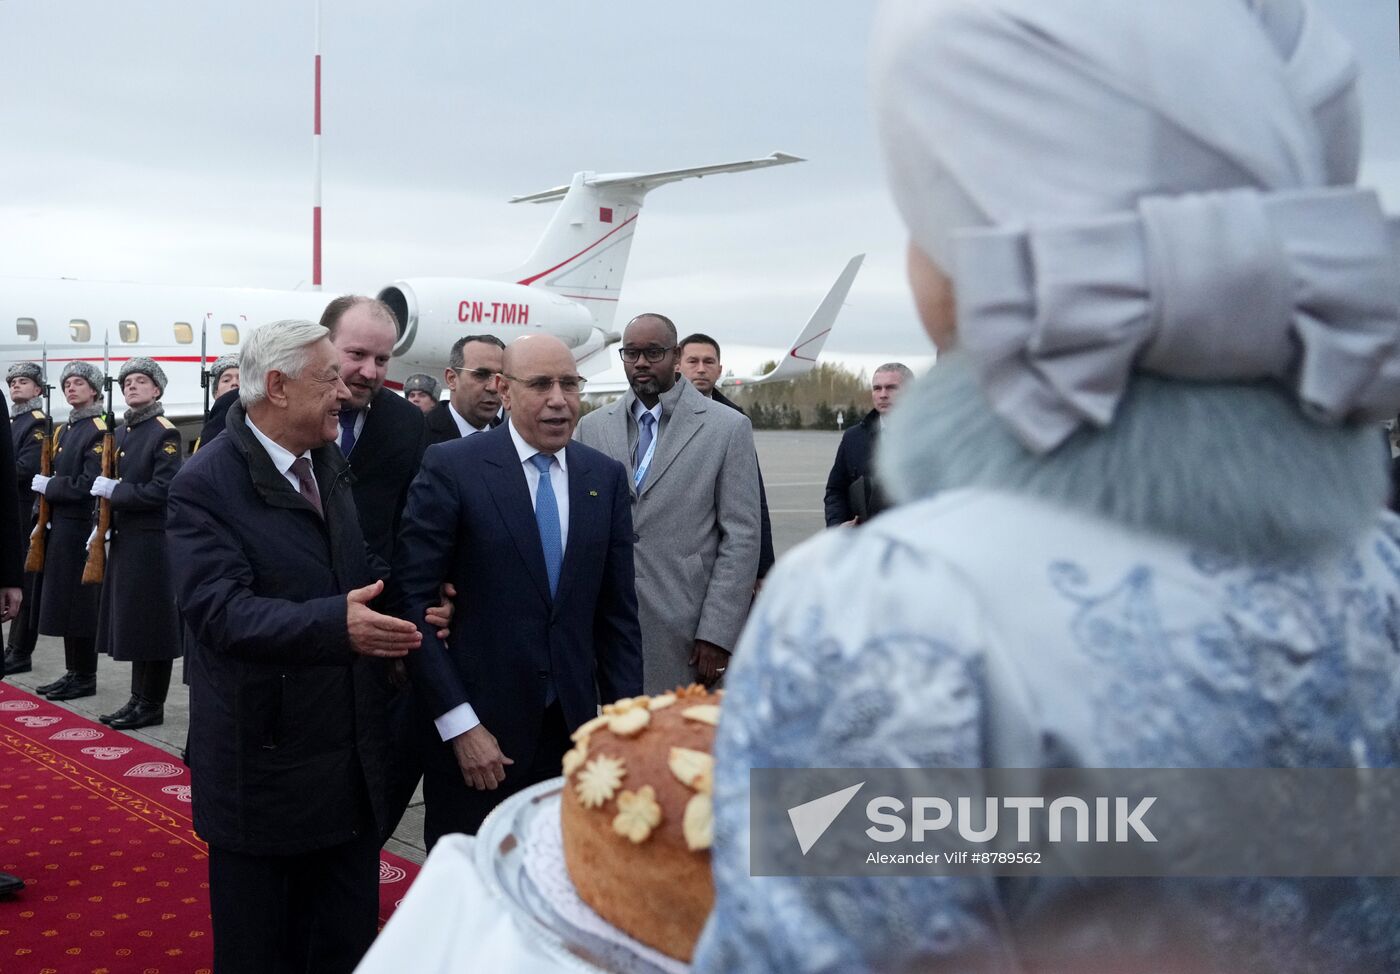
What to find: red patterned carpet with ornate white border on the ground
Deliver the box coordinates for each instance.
[0,683,419,974]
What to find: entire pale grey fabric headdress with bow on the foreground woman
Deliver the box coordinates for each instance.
[872,0,1400,453]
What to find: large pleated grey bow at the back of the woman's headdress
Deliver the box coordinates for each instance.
[952,189,1400,452]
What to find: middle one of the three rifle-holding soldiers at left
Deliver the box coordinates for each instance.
[31,361,106,700]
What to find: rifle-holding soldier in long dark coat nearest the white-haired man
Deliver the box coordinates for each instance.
[92,355,181,731]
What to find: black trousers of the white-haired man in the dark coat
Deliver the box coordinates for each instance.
[209,828,379,974]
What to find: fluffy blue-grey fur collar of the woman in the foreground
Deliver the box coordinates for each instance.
[876,353,1389,558]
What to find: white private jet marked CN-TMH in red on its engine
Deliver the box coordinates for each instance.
[0,153,858,421]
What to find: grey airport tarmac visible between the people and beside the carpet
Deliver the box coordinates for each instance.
[7,431,840,862]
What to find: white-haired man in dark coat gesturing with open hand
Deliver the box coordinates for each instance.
[168,322,431,971]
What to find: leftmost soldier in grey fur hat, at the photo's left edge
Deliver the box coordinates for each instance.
[4,362,49,676]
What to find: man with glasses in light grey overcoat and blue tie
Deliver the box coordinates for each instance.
[577,313,759,693]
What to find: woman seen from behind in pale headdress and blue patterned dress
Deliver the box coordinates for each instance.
[696,0,1400,974]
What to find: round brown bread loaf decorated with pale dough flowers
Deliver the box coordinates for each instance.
[560,686,721,961]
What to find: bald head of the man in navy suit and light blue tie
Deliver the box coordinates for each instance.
[501,334,581,453]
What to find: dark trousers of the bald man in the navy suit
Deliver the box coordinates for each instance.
[423,703,573,852]
